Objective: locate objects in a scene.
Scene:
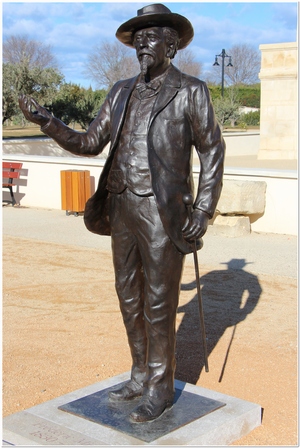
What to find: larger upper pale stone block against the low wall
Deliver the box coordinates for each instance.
[217,179,267,215]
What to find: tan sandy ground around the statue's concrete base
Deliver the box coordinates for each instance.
[3,235,298,446]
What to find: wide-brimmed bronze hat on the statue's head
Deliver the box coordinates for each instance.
[116,3,194,50]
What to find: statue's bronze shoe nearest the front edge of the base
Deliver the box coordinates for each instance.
[130,395,173,423]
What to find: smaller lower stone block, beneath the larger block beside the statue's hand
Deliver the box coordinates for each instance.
[211,215,251,237]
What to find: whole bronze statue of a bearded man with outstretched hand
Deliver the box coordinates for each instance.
[20,4,225,422]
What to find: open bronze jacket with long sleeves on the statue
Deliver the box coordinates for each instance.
[42,65,225,253]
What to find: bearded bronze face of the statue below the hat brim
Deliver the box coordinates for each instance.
[133,27,169,72]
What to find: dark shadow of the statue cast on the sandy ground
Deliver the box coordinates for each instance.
[175,259,262,384]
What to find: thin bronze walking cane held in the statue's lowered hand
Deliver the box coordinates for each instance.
[182,194,209,372]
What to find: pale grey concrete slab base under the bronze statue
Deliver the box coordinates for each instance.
[3,372,261,446]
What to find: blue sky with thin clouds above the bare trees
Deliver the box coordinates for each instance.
[2,1,297,87]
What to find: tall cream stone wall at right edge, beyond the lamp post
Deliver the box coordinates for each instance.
[258,42,298,159]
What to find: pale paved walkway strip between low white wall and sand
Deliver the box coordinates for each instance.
[2,206,298,278]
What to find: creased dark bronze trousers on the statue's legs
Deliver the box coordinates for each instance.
[110,189,185,399]
